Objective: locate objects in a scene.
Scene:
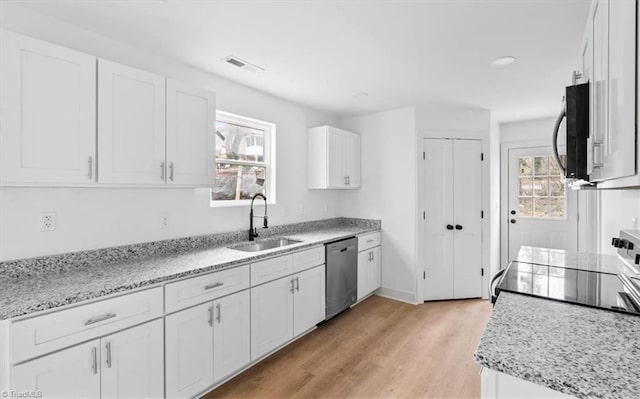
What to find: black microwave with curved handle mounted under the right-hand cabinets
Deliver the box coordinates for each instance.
[553,83,589,185]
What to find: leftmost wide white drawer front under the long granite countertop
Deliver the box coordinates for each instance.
[11,287,162,363]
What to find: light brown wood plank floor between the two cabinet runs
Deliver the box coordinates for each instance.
[206,296,491,399]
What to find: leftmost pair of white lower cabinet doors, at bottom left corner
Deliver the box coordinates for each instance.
[11,320,164,399]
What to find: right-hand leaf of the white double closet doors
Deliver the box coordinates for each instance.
[451,140,482,298]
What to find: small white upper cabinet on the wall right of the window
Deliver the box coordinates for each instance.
[307,126,360,189]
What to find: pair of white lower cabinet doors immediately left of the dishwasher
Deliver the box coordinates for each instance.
[251,265,326,361]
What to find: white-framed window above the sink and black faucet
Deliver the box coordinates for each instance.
[211,111,275,206]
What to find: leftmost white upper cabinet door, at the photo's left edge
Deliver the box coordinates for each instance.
[0,31,96,185]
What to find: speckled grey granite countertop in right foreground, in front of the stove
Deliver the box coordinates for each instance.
[475,292,640,399]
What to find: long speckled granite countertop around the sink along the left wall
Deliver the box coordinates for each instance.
[0,226,379,320]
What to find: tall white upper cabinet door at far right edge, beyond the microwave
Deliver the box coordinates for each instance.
[602,0,636,179]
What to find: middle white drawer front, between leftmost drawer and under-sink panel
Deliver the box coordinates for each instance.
[165,265,249,313]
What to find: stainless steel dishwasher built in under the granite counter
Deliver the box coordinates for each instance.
[325,237,358,320]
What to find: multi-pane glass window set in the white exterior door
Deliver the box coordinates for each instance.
[518,155,567,219]
